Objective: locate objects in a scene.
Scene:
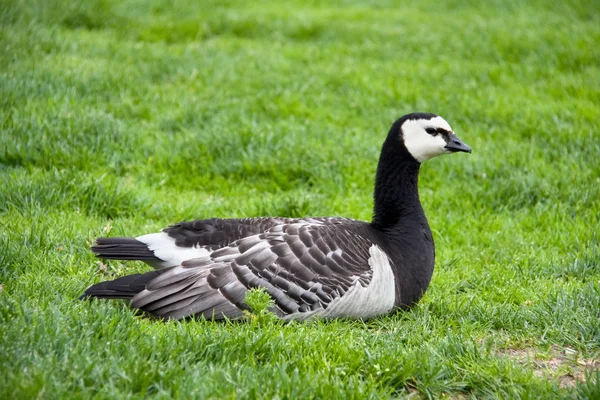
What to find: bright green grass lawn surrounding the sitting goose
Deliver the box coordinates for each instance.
[0,0,600,399]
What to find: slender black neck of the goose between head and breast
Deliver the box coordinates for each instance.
[372,134,424,230]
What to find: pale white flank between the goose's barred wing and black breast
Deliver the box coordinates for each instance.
[286,245,396,320]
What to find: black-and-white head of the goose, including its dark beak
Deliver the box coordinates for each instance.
[397,113,471,163]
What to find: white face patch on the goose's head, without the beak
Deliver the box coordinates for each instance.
[401,117,452,162]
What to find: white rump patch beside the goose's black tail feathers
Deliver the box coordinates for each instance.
[136,232,210,268]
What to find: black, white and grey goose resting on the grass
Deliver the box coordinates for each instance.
[81,113,471,321]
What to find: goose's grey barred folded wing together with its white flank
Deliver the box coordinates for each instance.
[132,220,394,319]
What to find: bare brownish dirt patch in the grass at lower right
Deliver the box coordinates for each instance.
[499,346,600,388]
